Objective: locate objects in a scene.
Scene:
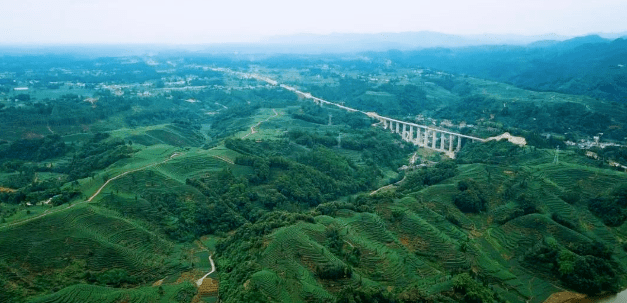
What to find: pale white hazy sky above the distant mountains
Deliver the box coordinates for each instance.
[0,0,627,44]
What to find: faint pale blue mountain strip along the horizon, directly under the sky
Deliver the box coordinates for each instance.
[0,31,627,56]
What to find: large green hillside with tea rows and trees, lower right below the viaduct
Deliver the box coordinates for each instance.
[218,144,627,302]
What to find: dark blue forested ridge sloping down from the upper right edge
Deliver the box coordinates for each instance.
[378,36,627,102]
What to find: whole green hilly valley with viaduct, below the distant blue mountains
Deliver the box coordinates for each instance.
[0,53,627,302]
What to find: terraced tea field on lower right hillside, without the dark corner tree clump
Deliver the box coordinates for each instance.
[213,144,627,302]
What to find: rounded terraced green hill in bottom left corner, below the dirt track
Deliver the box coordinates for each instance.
[0,204,189,295]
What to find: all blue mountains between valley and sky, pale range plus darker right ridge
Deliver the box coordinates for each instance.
[0,31,627,103]
